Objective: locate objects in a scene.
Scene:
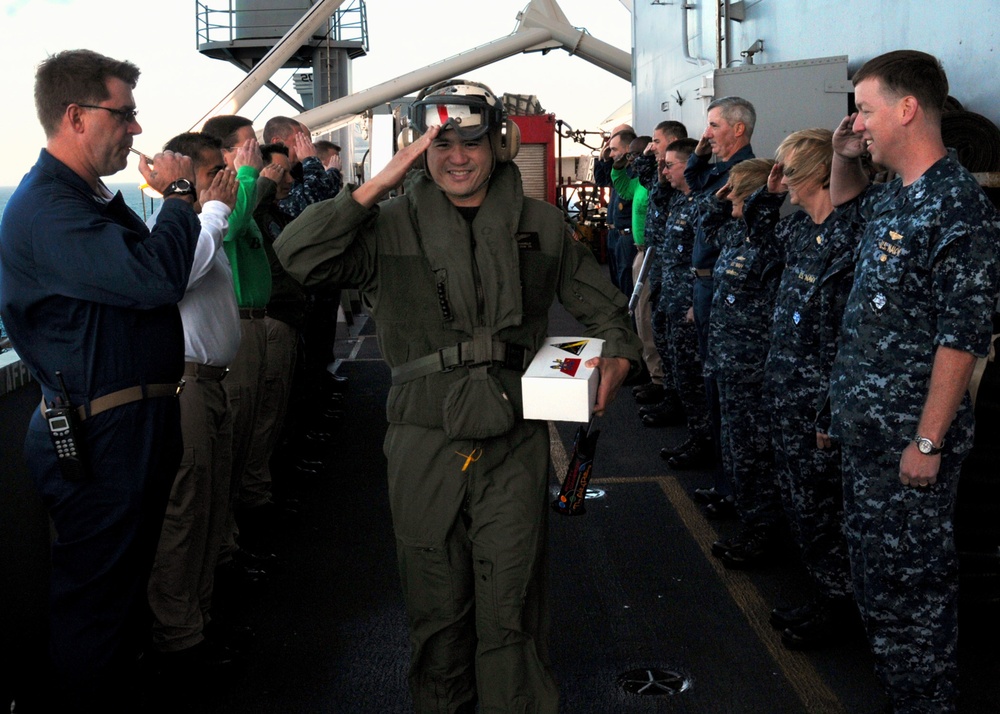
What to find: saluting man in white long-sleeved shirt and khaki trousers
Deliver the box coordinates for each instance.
[148,133,240,672]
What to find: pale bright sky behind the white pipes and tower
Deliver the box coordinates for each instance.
[0,0,632,186]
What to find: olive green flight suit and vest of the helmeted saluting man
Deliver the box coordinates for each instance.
[275,163,641,713]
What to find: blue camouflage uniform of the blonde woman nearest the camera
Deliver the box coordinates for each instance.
[764,202,864,602]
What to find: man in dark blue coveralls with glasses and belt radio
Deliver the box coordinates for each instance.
[0,50,199,712]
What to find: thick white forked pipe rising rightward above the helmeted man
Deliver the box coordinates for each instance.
[290,0,632,133]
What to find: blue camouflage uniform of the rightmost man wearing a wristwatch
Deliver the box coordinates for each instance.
[831,156,1000,714]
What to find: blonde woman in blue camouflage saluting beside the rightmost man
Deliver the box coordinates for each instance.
[765,129,862,649]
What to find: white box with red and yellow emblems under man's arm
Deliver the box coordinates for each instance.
[521,337,604,422]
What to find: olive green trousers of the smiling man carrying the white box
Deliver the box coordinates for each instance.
[385,422,559,714]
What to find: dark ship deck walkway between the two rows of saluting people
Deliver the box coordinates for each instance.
[0,298,1000,714]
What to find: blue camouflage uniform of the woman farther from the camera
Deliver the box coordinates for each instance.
[705,187,785,527]
